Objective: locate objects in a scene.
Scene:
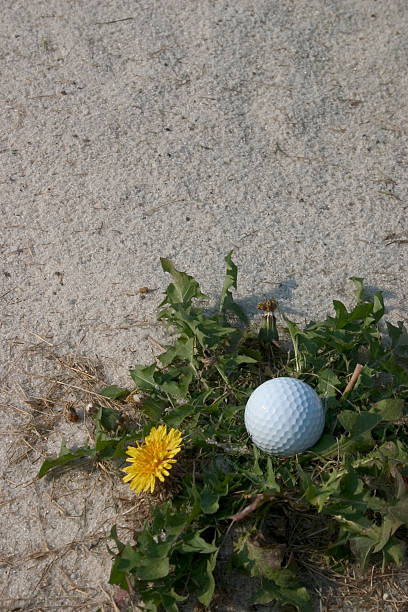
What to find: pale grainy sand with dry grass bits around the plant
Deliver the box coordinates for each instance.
[0,0,408,610]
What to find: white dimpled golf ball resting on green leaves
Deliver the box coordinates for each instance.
[245,377,325,457]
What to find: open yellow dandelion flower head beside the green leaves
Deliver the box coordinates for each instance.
[122,425,182,493]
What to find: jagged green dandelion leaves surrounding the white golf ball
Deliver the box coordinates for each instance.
[39,253,408,612]
